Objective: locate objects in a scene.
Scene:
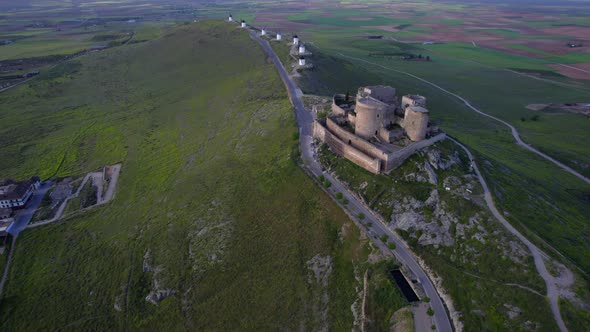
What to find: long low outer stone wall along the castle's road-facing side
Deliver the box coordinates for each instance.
[313,121,381,174]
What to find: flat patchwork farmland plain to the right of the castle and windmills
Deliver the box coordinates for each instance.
[250,1,590,275]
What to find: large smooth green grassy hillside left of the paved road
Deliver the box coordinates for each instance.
[0,22,408,330]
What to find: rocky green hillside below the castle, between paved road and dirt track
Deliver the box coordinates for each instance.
[319,140,555,331]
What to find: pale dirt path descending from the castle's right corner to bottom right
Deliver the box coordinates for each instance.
[447,136,567,332]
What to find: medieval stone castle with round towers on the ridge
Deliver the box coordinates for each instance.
[313,85,445,174]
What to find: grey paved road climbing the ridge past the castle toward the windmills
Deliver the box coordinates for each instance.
[250,31,452,332]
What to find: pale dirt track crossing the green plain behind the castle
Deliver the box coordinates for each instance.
[338,53,590,184]
